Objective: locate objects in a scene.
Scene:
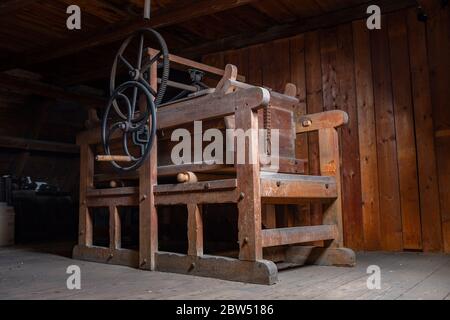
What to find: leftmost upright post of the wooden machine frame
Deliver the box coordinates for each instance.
[78,144,94,246]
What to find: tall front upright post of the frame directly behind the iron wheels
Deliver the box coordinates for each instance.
[139,50,158,270]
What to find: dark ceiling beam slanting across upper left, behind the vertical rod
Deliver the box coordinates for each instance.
[0,0,256,71]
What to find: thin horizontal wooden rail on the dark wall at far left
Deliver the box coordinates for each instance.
[0,136,80,154]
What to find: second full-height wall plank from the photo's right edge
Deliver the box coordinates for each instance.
[408,6,442,251]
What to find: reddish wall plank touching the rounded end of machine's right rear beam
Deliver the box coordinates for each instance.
[336,24,364,250]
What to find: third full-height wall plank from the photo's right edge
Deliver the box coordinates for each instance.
[388,12,422,249]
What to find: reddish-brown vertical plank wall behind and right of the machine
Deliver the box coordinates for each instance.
[203,6,450,252]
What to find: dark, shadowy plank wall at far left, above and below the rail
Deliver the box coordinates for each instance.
[0,88,83,196]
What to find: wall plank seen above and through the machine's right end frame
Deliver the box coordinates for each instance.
[305,31,323,225]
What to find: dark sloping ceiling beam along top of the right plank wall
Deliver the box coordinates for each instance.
[177,0,417,58]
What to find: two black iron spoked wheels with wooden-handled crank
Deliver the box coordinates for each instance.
[101,0,170,171]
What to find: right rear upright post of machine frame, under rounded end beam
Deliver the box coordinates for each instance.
[319,128,343,247]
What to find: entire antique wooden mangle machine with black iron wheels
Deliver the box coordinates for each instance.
[73,1,355,284]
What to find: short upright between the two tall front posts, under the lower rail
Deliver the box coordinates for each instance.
[187,203,203,257]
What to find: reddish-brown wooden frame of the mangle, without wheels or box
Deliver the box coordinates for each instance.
[74,51,355,284]
